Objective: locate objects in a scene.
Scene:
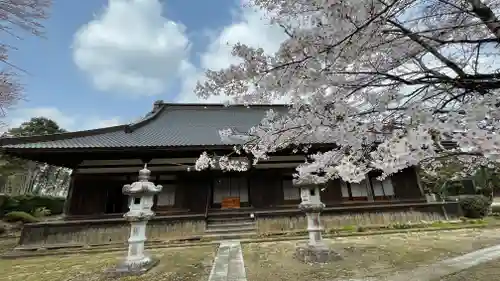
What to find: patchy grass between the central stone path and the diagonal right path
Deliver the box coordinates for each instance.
[243,229,500,281]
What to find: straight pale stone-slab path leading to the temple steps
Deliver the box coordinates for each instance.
[208,241,247,281]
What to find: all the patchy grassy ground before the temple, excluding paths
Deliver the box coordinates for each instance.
[0,226,500,281]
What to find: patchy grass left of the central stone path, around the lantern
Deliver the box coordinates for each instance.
[0,246,216,281]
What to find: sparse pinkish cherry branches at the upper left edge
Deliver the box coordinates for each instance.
[0,0,52,118]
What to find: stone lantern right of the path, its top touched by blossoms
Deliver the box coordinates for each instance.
[294,179,340,263]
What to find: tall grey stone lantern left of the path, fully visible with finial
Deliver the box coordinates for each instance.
[108,165,162,275]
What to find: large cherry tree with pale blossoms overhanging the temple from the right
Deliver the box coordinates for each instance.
[196,0,500,183]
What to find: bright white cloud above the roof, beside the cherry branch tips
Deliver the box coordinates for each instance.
[177,2,286,103]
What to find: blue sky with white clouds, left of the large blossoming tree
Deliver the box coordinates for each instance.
[4,0,284,130]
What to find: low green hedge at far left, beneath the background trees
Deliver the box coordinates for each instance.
[0,195,64,215]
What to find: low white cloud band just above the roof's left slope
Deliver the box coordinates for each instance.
[0,106,121,131]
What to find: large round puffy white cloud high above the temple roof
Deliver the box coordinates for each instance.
[73,0,189,95]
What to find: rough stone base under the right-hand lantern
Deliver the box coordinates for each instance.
[294,243,342,263]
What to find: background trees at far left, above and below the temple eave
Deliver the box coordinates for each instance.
[0,117,70,195]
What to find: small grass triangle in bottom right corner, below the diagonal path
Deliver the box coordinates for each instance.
[434,260,500,281]
